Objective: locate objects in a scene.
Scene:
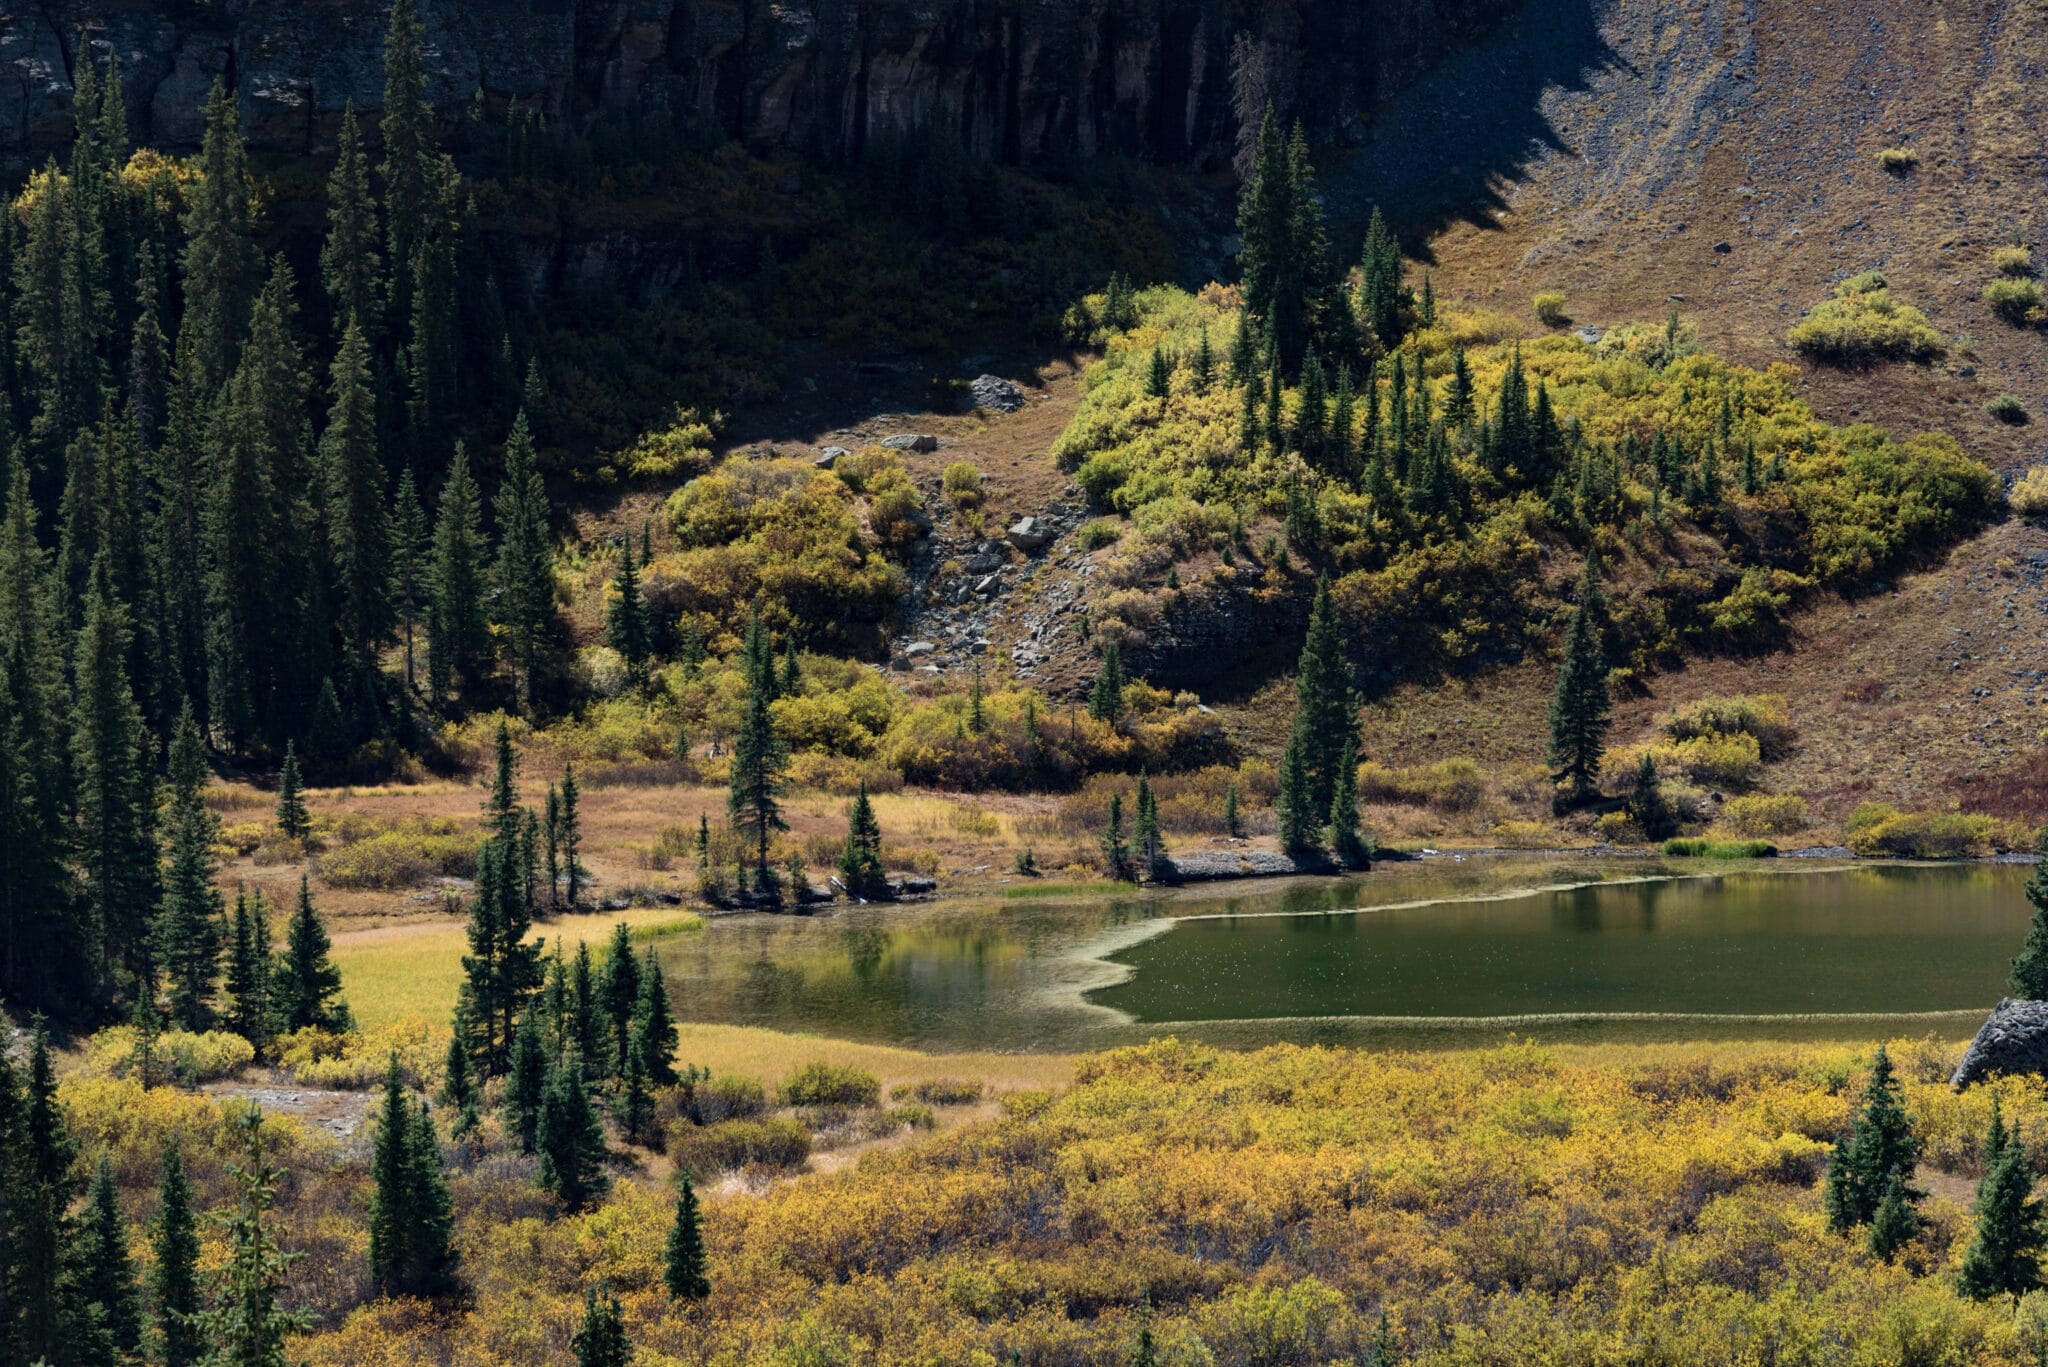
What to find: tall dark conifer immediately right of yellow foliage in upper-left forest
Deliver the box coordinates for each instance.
[178,80,262,393]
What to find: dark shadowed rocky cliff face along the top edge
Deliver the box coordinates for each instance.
[16,0,1516,166]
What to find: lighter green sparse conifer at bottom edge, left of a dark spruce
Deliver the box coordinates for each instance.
[199,1109,313,1367]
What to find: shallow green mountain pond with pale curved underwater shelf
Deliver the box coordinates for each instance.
[659,857,2028,1051]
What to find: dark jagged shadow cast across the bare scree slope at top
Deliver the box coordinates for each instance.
[1323,0,1634,260]
